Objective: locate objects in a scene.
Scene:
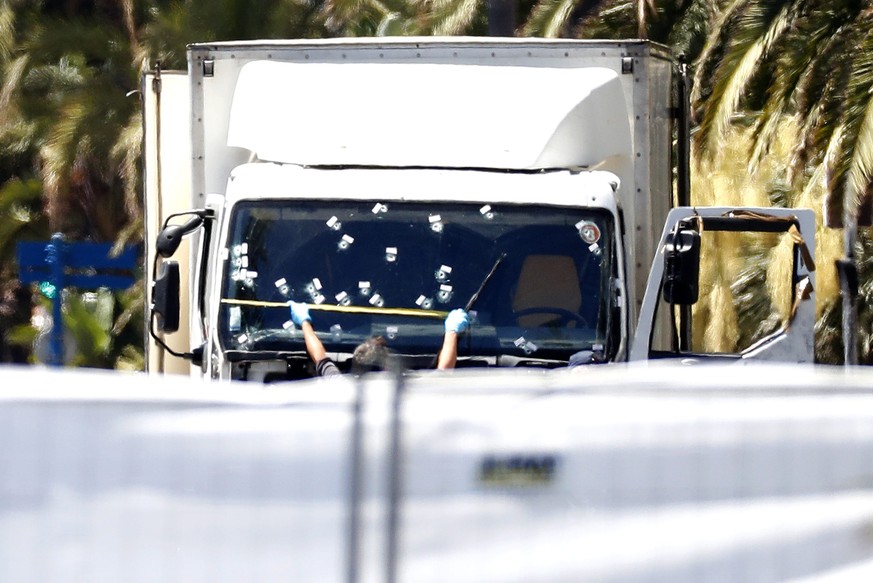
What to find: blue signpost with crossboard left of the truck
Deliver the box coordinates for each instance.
[16,233,138,366]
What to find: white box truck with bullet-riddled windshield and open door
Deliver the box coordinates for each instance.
[143,38,815,382]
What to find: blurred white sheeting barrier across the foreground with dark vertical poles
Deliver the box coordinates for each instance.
[0,363,873,583]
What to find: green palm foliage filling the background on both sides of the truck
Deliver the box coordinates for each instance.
[0,0,860,367]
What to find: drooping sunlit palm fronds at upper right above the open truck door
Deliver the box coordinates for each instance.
[694,0,873,362]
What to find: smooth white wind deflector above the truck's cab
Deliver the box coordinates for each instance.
[228,61,632,170]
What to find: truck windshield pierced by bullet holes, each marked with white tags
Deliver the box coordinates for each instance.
[219,201,613,359]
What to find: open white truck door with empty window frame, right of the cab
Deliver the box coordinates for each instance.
[630,207,815,362]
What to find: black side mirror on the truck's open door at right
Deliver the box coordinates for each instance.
[663,228,700,306]
